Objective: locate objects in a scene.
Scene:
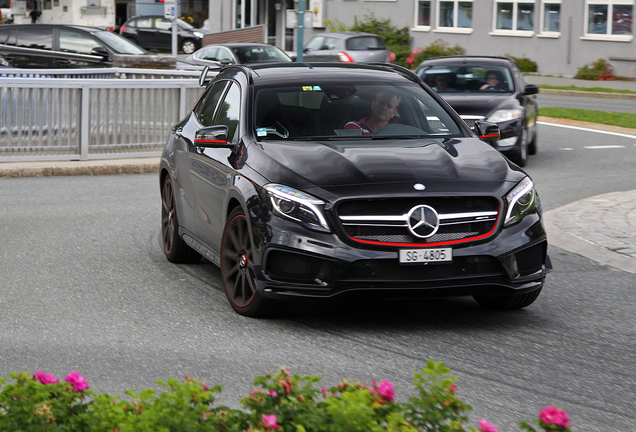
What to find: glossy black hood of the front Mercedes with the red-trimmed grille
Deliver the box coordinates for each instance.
[245,138,524,189]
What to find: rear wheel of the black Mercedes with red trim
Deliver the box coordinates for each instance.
[161,176,201,264]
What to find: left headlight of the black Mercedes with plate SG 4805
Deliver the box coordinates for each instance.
[265,184,331,232]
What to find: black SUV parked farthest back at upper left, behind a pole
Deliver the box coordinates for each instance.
[119,15,207,54]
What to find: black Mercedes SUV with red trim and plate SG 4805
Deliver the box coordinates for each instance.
[159,63,552,316]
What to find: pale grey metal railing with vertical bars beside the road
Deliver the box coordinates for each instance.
[0,69,203,162]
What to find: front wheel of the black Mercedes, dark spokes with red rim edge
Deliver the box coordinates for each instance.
[221,207,279,317]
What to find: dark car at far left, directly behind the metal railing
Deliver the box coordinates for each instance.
[0,24,166,69]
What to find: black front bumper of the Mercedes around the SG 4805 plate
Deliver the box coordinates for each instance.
[254,214,552,300]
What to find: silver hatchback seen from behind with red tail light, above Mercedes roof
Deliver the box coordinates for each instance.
[303,32,395,63]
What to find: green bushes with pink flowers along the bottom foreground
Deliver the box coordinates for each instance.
[0,360,571,432]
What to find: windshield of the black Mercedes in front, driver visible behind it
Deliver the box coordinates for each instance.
[254,82,461,140]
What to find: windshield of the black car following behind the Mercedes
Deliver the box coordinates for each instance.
[417,65,514,93]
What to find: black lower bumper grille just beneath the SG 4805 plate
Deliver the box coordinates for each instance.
[339,256,504,282]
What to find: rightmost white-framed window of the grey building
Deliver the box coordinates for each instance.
[586,0,634,40]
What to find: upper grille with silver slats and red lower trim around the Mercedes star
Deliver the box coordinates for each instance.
[336,197,499,246]
